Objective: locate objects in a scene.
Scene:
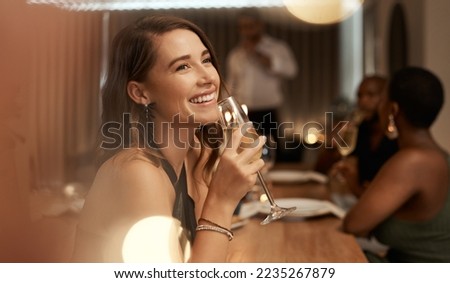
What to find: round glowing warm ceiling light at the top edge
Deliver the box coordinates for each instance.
[283,0,364,25]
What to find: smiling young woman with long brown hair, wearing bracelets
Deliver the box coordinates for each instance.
[73,16,264,262]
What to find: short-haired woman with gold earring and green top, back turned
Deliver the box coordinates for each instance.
[343,67,450,262]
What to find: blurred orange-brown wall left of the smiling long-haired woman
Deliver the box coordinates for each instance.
[0,0,101,262]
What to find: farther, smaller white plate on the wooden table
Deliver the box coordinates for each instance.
[268,170,328,184]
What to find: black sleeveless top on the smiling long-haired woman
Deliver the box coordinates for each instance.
[161,159,197,243]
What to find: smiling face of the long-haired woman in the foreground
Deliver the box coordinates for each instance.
[144,29,220,124]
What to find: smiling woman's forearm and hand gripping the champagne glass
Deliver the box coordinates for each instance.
[190,127,265,262]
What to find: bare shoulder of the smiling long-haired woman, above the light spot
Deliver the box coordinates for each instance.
[86,150,175,223]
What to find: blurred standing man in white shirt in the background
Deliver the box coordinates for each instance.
[227,8,297,147]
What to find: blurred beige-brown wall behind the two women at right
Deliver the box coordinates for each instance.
[377,0,450,152]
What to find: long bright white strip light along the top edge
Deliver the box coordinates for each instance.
[27,0,283,11]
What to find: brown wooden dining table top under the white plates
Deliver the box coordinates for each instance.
[227,166,367,263]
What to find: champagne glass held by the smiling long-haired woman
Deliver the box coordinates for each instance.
[218,96,296,225]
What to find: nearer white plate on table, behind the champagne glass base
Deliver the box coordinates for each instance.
[260,198,345,218]
